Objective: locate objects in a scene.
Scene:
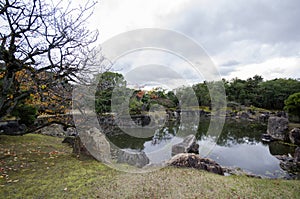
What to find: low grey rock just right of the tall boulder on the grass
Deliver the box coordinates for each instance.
[117,150,150,168]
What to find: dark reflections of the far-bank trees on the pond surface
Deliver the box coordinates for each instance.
[106,118,267,150]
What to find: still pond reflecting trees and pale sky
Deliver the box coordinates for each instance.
[104,118,295,178]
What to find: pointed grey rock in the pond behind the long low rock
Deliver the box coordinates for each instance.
[172,135,199,155]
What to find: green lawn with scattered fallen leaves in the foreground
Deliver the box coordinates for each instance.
[0,134,300,198]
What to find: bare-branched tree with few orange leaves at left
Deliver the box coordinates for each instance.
[0,0,98,119]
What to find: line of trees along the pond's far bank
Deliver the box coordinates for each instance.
[95,72,300,114]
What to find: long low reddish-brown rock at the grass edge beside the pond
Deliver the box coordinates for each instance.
[167,153,224,175]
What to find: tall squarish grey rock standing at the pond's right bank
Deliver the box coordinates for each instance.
[267,117,289,140]
